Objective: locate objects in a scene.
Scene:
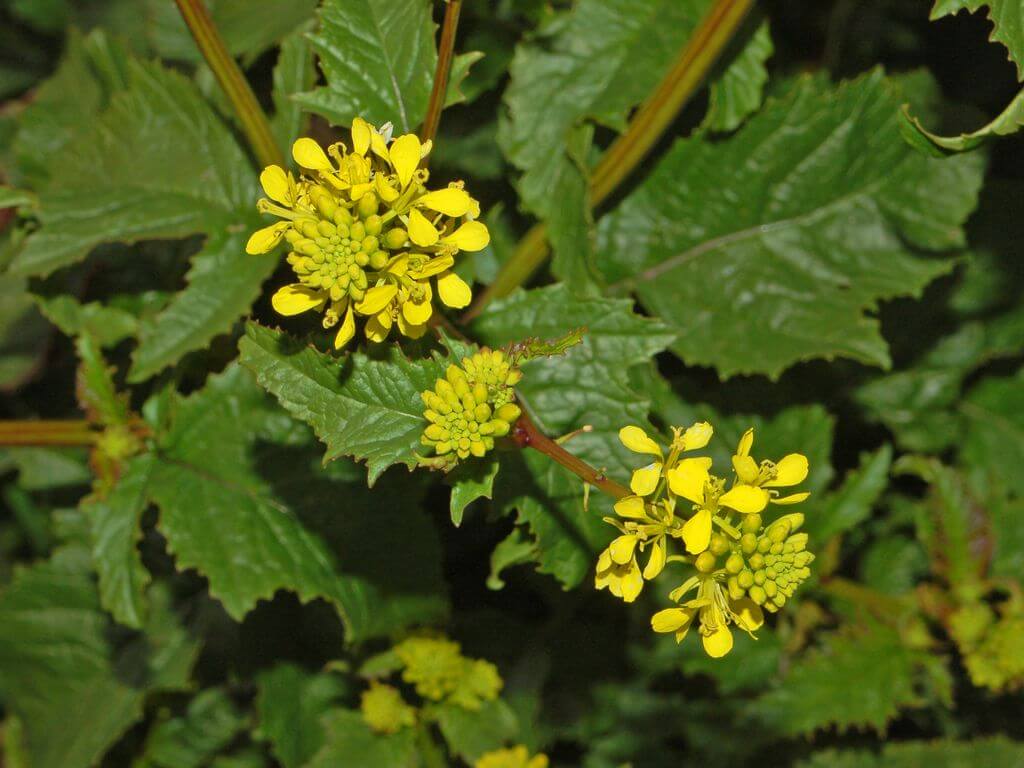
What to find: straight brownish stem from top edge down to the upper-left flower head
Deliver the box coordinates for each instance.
[175,0,285,166]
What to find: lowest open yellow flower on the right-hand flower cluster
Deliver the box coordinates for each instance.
[650,574,764,658]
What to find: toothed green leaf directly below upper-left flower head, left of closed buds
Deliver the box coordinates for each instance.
[239,323,456,485]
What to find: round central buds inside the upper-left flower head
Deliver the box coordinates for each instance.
[285,186,393,301]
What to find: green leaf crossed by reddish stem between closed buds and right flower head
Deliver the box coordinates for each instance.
[472,284,672,588]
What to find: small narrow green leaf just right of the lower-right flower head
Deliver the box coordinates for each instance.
[804,444,893,548]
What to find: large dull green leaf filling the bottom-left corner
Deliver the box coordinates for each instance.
[0,549,197,768]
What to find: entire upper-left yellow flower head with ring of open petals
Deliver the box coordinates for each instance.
[246,118,489,349]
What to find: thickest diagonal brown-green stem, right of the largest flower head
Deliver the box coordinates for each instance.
[463,0,754,323]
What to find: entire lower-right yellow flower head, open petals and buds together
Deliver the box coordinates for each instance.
[595,422,814,657]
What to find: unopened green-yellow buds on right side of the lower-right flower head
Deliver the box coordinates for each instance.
[693,512,814,612]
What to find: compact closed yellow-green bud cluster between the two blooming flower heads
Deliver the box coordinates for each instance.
[420,348,522,470]
